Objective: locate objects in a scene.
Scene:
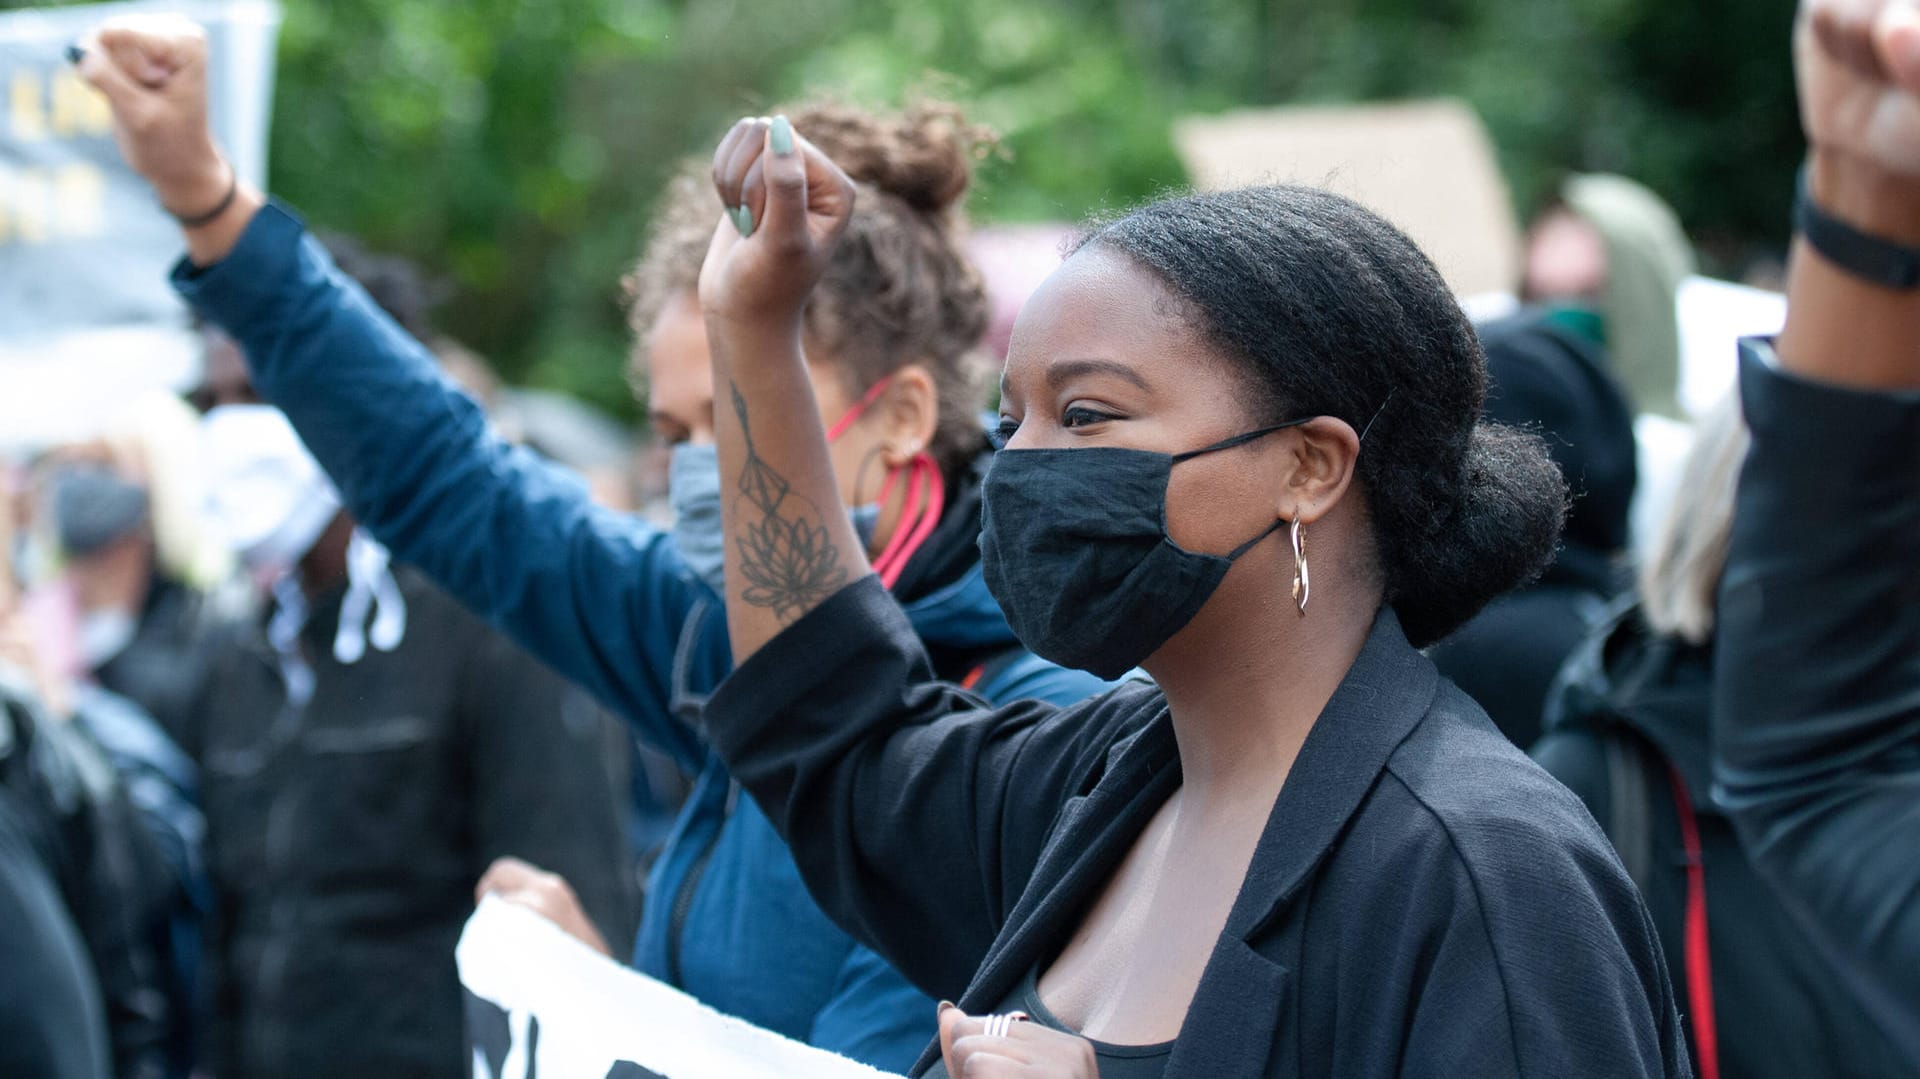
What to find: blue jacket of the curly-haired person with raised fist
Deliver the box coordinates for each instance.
[173,205,1106,1071]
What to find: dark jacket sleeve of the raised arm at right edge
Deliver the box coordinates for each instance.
[1713,346,1920,1054]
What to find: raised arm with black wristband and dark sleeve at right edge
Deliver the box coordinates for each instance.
[1713,0,1920,1064]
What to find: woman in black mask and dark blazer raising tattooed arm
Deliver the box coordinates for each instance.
[701,117,1688,1079]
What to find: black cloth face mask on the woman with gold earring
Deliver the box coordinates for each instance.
[979,417,1313,678]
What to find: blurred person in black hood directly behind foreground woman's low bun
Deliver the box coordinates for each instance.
[1427,311,1634,749]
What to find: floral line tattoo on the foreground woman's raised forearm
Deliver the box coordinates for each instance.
[730,386,847,626]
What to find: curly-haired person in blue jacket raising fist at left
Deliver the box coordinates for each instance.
[84,50,1102,1069]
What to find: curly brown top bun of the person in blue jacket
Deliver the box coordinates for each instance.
[789,102,996,213]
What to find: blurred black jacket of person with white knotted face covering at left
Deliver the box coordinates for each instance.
[194,568,632,1077]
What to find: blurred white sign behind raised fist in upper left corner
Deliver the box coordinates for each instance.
[0,0,280,451]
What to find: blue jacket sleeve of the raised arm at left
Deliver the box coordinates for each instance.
[173,205,714,770]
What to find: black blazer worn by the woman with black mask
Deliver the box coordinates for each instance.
[708,578,1688,1079]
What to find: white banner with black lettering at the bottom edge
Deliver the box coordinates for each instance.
[455,897,913,1079]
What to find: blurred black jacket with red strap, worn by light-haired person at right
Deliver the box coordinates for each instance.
[1532,607,1920,1079]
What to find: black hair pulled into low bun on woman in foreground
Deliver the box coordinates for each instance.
[1081,184,1567,647]
